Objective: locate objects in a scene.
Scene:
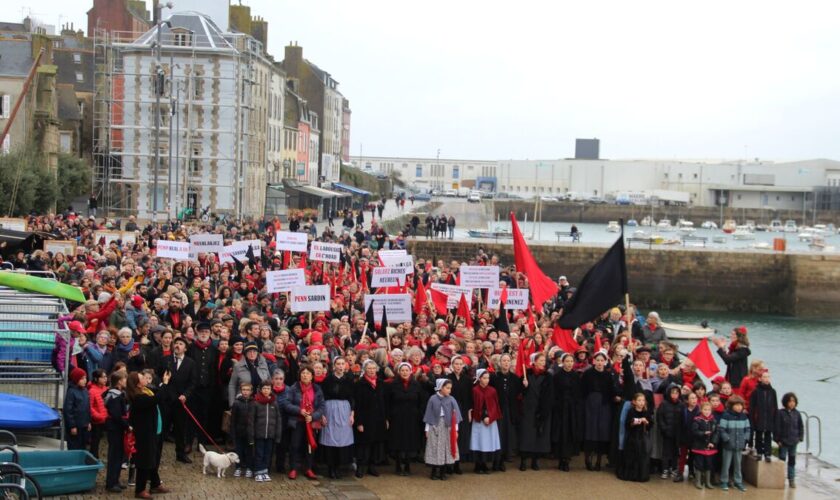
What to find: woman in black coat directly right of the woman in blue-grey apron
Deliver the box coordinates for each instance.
[353,359,388,478]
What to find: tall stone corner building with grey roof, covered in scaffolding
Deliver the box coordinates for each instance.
[93,12,278,220]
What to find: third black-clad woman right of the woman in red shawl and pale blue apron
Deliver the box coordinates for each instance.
[551,352,583,472]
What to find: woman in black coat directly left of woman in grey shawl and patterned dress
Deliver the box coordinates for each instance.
[385,363,427,476]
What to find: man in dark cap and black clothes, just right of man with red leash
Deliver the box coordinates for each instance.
[186,322,222,453]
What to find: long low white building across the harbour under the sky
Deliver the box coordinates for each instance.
[352,156,840,209]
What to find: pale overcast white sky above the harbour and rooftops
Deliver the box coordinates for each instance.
[8,0,840,159]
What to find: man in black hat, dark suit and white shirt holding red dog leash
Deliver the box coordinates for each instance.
[165,337,196,464]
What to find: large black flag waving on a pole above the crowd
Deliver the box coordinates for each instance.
[560,234,627,328]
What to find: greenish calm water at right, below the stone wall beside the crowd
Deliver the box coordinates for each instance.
[659,311,840,465]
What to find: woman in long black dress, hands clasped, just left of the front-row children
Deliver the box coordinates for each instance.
[616,392,653,482]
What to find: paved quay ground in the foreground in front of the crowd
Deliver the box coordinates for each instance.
[69,450,840,500]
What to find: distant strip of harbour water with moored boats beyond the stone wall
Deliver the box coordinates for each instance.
[466,221,840,253]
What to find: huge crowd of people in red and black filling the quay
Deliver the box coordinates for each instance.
[0,201,803,498]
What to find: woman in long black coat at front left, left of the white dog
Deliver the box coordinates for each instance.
[127,371,170,498]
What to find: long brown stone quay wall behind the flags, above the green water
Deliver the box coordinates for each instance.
[409,238,840,318]
